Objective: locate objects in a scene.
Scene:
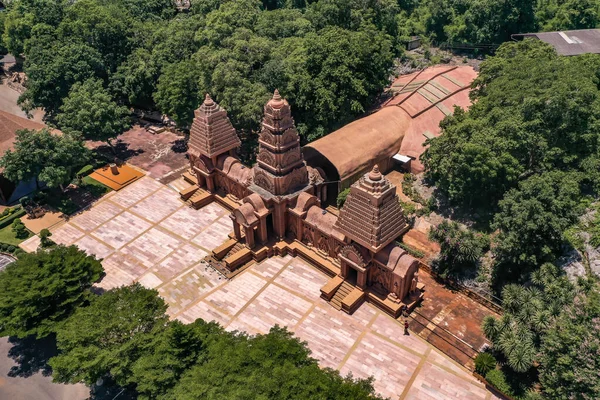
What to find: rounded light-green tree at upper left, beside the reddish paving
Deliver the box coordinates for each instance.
[56,79,130,148]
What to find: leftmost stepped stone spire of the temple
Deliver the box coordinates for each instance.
[188,93,241,158]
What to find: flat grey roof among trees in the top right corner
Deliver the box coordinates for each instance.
[512,29,600,56]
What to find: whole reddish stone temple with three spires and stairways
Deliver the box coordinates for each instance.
[180,90,423,317]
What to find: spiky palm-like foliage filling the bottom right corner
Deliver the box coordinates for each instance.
[482,264,600,400]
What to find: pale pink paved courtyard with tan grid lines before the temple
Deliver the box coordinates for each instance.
[22,177,495,400]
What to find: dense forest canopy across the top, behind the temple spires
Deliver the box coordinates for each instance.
[0,0,599,150]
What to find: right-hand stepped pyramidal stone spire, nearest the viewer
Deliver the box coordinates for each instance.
[335,165,408,253]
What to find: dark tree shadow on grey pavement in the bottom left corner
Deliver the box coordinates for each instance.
[8,335,58,378]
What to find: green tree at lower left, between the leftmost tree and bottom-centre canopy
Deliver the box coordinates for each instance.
[48,283,168,386]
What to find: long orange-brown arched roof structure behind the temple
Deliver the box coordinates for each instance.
[303,66,477,181]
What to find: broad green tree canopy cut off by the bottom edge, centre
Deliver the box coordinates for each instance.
[171,327,380,400]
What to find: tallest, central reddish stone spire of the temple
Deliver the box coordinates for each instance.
[254,90,308,195]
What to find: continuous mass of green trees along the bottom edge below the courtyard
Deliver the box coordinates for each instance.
[49,284,379,400]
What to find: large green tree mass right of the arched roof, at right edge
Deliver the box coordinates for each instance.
[423,40,600,283]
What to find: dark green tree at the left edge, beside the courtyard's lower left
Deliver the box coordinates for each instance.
[0,246,103,338]
